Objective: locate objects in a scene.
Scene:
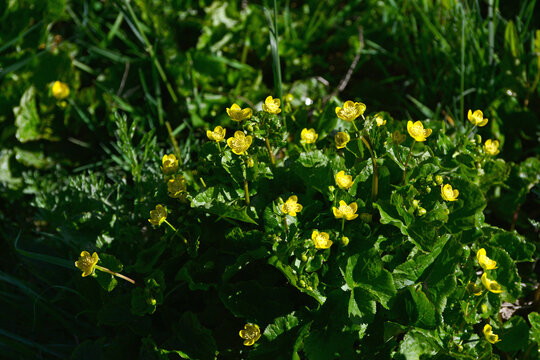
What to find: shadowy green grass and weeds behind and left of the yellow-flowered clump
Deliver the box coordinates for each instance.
[0,0,540,358]
